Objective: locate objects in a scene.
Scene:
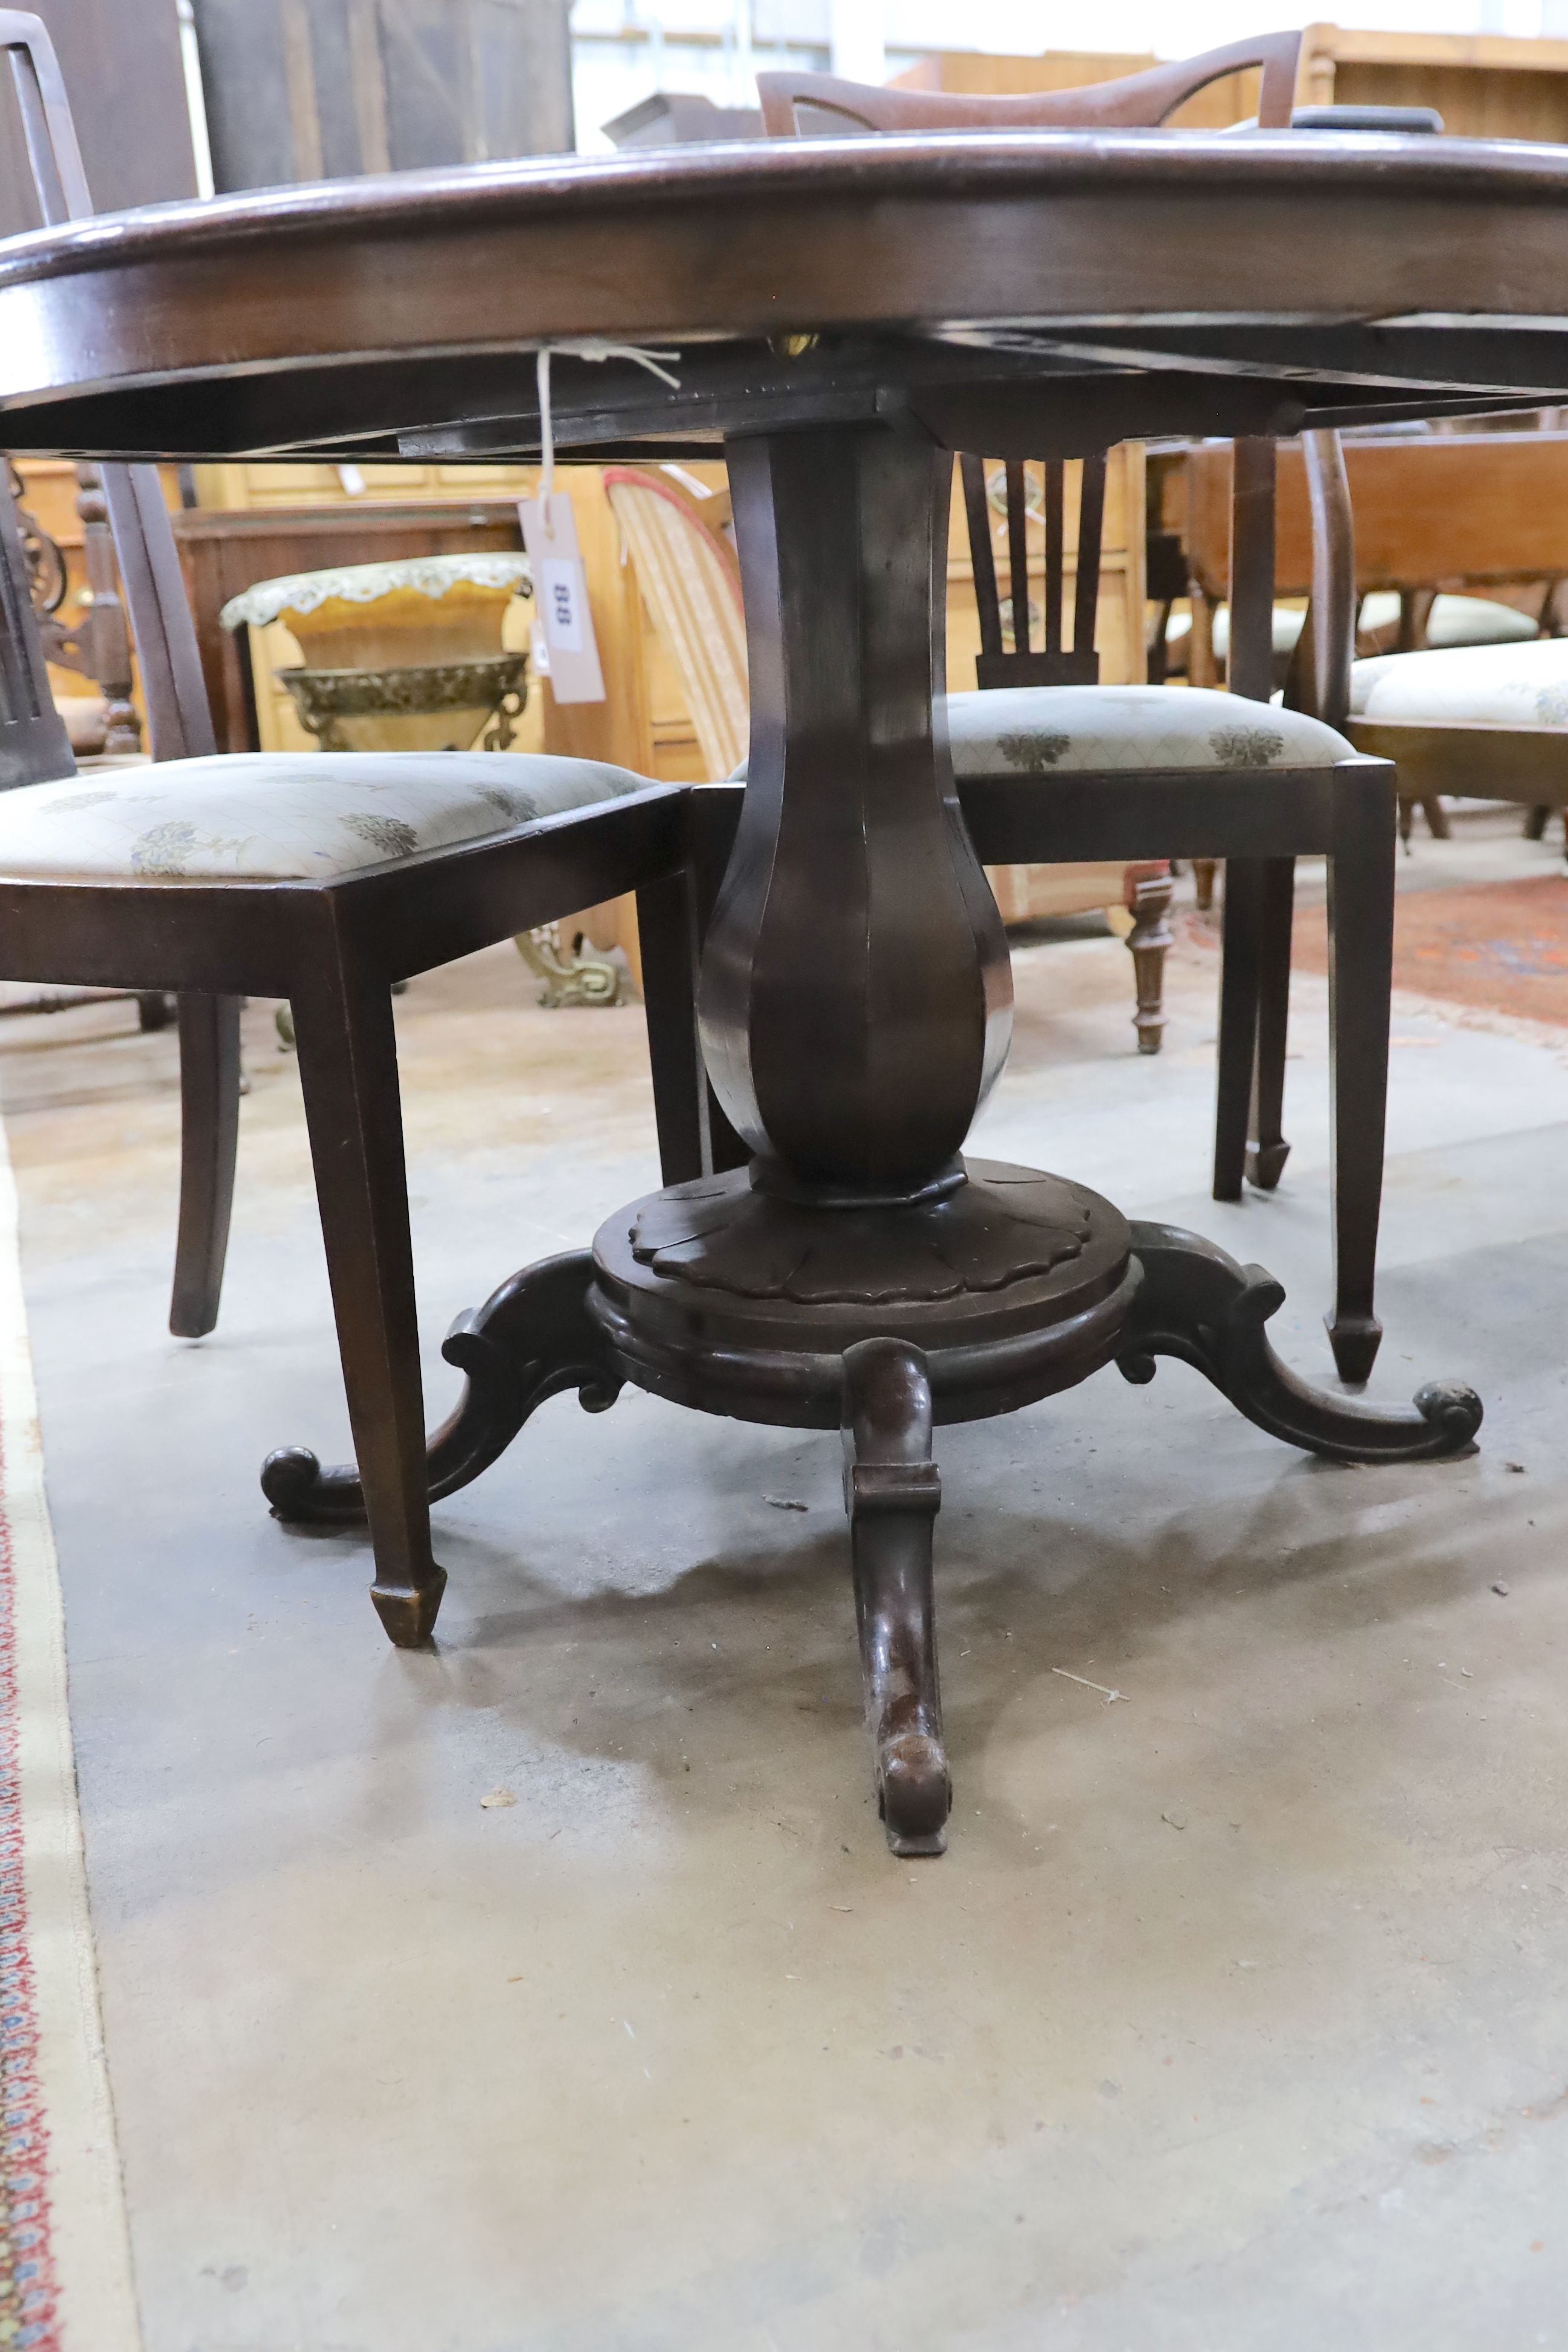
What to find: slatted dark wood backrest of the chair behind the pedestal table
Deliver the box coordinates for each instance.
[757,33,1350,701]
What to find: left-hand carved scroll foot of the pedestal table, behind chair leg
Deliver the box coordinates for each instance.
[261,1249,621,1524]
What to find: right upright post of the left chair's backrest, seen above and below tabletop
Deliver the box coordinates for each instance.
[0,10,217,760]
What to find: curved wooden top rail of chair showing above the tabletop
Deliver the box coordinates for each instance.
[757,33,1302,139]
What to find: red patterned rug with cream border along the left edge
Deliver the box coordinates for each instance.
[0,1134,141,2352]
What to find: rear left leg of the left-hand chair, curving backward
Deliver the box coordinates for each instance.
[169,995,240,1338]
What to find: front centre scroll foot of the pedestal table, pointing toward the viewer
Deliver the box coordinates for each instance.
[844,1338,952,1856]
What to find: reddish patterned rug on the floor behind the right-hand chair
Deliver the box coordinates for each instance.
[1259,875,1568,1028]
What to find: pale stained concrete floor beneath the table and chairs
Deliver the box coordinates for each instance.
[0,821,1568,2352]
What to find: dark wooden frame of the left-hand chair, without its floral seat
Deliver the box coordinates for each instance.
[0,11,762,1644]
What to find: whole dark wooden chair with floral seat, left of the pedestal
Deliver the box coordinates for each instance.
[0,10,701,1647]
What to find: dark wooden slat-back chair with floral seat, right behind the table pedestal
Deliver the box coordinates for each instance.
[757,33,1394,1383]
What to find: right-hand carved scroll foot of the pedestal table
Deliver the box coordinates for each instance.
[1117,1223,1481,1463]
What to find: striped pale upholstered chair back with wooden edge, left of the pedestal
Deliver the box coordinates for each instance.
[604,466,748,783]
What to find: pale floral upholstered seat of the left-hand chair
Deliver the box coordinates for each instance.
[0,750,651,882]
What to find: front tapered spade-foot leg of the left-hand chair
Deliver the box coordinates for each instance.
[292,950,446,1648]
